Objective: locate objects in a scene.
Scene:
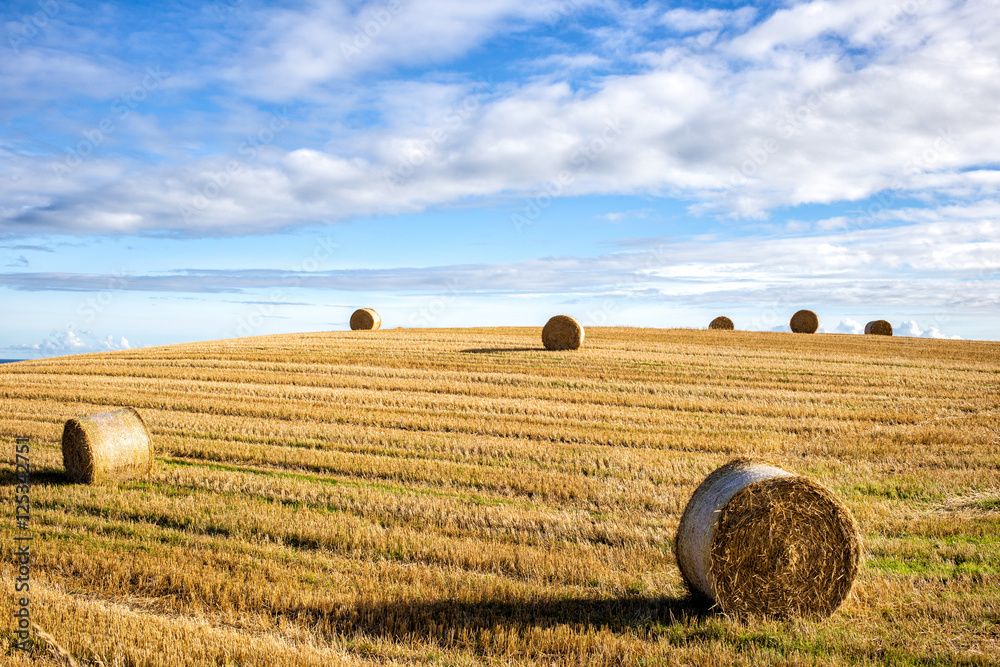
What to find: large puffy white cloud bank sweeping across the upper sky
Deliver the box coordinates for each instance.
[0,0,1000,235]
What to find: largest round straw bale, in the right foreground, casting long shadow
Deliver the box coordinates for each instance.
[674,459,861,618]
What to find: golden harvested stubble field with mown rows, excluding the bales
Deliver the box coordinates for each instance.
[0,328,1000,667]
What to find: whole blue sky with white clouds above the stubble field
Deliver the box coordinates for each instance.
[0,0,1000,358]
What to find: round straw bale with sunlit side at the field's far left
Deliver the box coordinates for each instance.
[62,408,153,484]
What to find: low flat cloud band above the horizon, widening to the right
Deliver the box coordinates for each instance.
[0,222,1000,322]
